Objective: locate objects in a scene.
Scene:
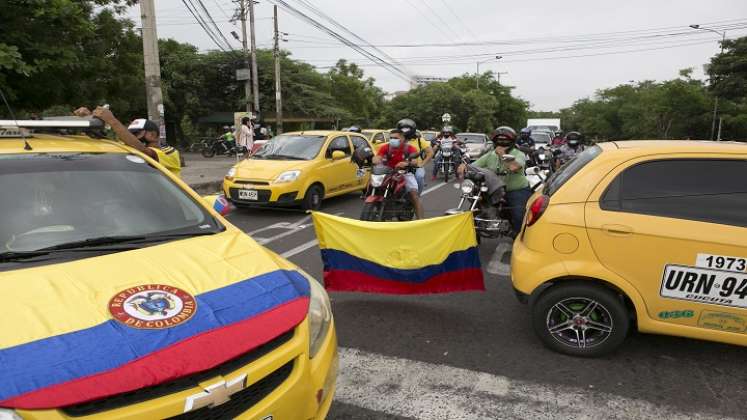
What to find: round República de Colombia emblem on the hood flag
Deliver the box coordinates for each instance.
[109,284,197,329]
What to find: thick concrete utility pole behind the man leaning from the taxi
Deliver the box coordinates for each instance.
[140,0,166,141]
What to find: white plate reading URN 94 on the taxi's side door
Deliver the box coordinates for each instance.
[659,264,747,308]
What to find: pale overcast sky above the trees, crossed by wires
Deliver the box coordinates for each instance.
[130,0,747,110]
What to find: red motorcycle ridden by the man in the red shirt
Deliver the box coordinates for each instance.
[360,162,417,222]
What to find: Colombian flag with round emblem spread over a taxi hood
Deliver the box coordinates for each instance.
[0,230,309,409]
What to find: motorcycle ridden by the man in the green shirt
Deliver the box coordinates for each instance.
[446,161,513,241]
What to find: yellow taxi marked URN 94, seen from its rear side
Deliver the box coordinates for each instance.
[511,141,747,356]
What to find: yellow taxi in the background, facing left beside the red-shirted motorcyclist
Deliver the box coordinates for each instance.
[223,131,372,210]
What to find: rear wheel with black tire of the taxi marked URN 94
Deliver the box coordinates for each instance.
[532,282,630,357]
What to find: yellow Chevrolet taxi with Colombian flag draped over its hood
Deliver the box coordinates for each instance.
[0,120,338,420]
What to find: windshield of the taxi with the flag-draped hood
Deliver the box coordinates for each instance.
[0,153,223,258]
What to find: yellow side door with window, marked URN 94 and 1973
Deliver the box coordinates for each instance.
[585,154,747,345]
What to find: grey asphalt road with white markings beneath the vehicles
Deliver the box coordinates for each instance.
[224,173,747,419]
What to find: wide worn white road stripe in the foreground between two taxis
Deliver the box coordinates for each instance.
[335,348,723,420]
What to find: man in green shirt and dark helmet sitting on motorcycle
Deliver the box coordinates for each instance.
[457,126,532,236]
